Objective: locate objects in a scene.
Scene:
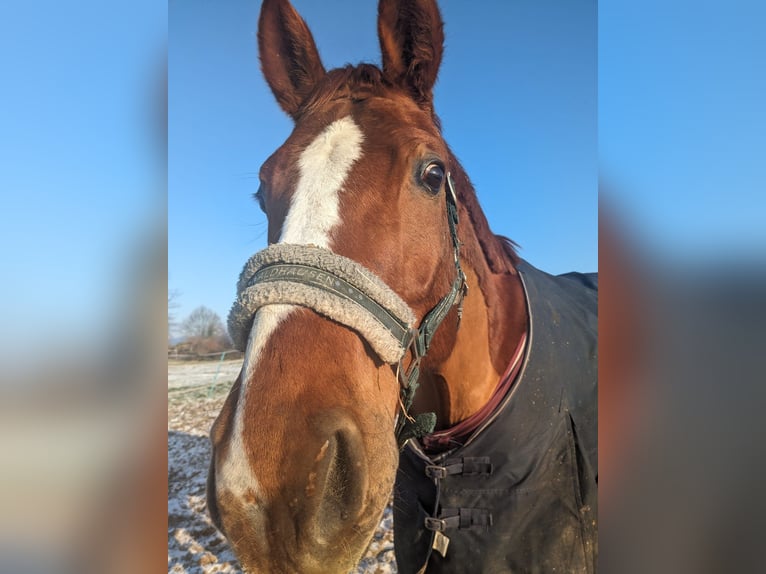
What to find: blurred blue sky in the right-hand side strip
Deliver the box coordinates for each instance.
[598,0,766,266]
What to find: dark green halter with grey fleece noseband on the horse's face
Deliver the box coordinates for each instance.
[228,173,467,447]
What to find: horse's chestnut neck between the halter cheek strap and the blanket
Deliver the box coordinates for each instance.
[415,173,528,428]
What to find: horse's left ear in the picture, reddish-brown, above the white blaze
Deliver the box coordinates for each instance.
[258,0,325,117]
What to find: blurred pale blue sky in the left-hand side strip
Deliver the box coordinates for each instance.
[0,0,167,355]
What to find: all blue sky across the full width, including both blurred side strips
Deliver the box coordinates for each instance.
[0,0,766,352]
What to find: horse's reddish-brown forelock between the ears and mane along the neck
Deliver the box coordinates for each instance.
[295,63,520,273]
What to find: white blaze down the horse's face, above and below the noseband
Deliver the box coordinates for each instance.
[216,116,363,500]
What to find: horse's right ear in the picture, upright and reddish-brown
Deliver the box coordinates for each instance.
[378,0,444,109]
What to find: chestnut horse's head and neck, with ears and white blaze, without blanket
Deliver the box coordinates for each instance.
[208,0,525,573]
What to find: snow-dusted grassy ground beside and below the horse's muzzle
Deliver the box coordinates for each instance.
[168,361,397,574]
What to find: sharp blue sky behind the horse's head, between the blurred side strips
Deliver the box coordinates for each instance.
[168,0,598,330]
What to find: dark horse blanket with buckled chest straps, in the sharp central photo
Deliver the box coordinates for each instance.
[394,262,598,574]
